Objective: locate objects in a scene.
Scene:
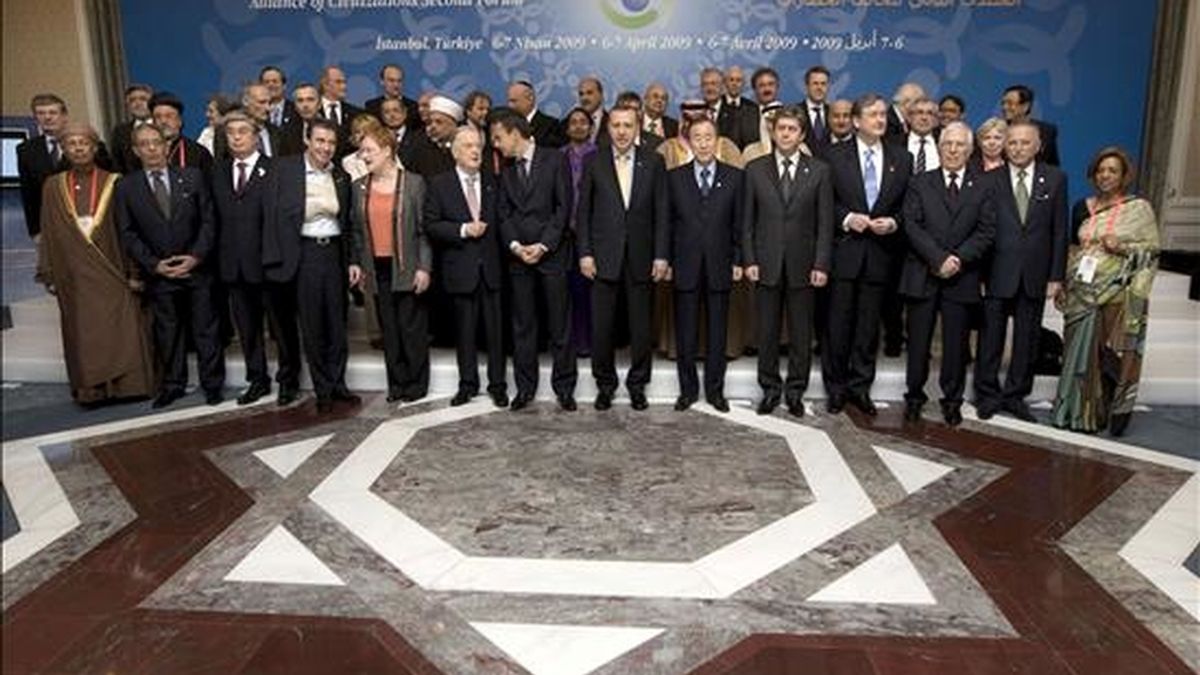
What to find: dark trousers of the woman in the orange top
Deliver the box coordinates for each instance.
[374,258,430,399]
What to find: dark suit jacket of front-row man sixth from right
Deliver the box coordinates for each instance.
[667,161,744,291]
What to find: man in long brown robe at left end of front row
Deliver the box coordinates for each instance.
[37,124,155,406]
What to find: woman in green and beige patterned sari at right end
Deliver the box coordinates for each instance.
[1052,148,1159,436]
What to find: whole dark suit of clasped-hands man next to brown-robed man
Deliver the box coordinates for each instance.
[115,167,224,393]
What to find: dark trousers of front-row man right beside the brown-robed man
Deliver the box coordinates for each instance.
[150,277,224,392]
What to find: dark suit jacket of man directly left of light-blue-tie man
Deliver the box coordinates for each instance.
[742,153,834,288]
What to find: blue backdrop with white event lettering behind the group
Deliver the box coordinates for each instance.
[121,0,1158,195]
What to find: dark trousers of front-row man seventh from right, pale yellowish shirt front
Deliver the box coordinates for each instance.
[592,258,654,394]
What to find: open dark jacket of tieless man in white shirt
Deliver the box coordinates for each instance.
[263,155,350,282]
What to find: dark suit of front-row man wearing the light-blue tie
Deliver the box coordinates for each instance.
[822,141,912,396]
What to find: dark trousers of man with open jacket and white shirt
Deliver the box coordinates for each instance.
[295,237,349,399]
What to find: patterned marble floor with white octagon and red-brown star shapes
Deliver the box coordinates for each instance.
[0,383,1200,675]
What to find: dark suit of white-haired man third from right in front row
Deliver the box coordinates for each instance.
[900,169,996,406]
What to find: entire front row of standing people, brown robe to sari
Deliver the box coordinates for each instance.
[40,95,1157,432]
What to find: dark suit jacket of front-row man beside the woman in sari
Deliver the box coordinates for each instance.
[986,162,1069,298]
